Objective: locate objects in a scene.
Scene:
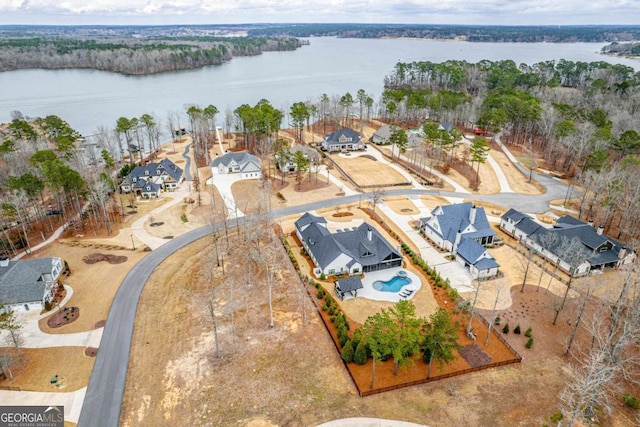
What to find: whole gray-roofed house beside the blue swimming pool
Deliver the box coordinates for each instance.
[295,212,402,277]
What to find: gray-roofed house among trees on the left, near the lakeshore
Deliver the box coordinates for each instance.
[120,159,183,197]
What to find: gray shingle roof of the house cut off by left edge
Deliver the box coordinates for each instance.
[0,258,60,305]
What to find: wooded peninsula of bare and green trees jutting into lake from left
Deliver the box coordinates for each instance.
[0,35,301,75]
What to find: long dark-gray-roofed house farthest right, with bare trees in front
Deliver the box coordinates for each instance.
[500,209,636,276]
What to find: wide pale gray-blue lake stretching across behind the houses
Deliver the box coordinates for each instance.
[0,37,640,135]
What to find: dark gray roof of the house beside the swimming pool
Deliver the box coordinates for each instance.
[295,214,402,269]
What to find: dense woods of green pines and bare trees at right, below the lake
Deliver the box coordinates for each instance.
[380,56,640,243]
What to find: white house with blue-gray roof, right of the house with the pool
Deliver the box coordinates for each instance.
[420,203,500,277]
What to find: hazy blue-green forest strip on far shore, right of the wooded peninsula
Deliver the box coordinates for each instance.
[248,24,640,43]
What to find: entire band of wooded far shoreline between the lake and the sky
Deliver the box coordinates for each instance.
[0,24,640,75]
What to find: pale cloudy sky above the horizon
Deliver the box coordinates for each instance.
[0,0,640,25]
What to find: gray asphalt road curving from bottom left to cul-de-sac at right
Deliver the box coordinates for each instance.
[78,169,567,427]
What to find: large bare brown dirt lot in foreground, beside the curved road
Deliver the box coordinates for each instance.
[116,224,600,426]
